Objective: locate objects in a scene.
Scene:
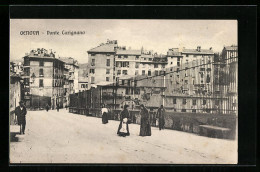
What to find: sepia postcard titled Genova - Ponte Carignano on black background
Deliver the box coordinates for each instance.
[9,18,239,165]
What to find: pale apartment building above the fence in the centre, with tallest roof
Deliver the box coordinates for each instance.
[88,40,167,88]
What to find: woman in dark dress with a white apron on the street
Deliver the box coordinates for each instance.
[117,105,130,137]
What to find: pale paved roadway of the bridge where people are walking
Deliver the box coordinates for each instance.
[10,109,237,164]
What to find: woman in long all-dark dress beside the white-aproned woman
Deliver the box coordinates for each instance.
[139,105,152,136]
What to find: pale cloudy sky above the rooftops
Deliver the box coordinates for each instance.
[10,19,238,63]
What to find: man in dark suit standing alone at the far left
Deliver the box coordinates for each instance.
[15,101,27,134]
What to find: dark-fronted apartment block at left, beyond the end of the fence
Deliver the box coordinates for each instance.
[24,48,64,109]
